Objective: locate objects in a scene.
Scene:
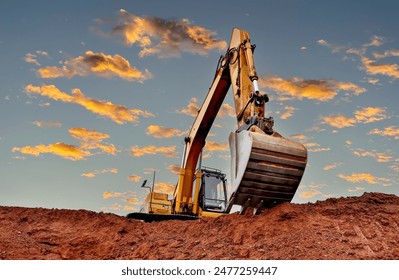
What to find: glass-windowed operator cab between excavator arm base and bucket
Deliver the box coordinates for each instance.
[198,168,227,212]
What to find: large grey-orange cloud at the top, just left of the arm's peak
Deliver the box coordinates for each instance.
[96,9,227,58]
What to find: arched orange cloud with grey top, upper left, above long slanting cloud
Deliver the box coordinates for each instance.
[37,51,151,82]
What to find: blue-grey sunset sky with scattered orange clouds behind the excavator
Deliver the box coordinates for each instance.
[0,0,399,215]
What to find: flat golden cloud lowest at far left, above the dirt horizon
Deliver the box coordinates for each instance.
[11,142,91,161]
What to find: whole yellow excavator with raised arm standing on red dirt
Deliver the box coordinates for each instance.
[127,28,307,222]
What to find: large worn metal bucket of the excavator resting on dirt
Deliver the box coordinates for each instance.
[228,131,307,211]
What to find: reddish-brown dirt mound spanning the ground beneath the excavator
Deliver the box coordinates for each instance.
[0,193,399,259]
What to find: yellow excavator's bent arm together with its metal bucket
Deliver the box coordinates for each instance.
[173,28,307,215]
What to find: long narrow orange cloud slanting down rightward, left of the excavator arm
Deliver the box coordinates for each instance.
[25,84,154,124]
